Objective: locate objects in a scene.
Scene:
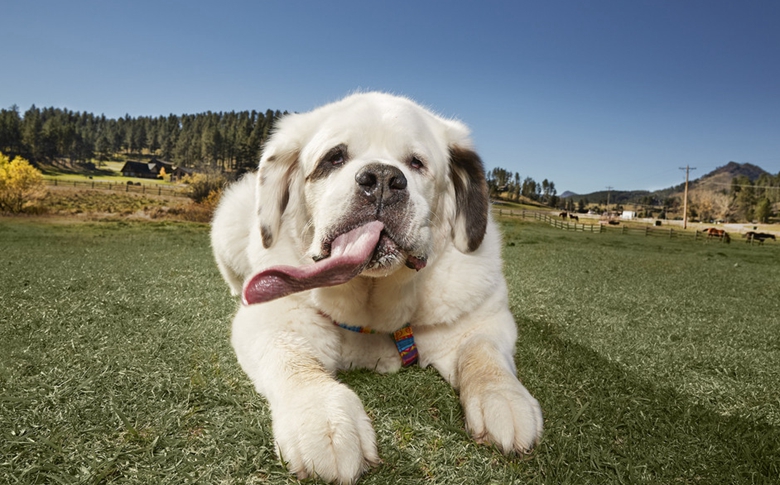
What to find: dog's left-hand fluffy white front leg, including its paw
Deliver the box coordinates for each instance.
[232,300,379,483]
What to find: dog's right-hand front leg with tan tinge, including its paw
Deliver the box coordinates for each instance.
[414,305,543,453]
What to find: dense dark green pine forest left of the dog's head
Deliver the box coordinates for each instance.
[0,105,287,171]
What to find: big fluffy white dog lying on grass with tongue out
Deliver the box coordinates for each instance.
[211,93,542,483]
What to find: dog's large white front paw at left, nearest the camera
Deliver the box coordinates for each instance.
[273,383,379,484]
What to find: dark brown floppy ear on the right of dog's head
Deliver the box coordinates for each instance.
[450,145,490,253]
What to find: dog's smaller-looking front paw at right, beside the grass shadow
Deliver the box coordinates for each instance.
[461,376,544,454]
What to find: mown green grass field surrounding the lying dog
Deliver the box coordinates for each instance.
[0,218,780,485]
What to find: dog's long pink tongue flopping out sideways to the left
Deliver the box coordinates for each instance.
[243,221,384,305]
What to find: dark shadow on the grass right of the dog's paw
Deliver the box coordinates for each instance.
[517,319,780,483]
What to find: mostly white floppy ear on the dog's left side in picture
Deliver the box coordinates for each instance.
[257,120,300,249]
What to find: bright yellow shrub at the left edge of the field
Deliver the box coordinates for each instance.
[0,153,46,212]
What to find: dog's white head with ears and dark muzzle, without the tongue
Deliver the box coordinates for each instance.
[257,93,489,276]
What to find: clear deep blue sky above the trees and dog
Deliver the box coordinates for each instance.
[0,0,780,193]
